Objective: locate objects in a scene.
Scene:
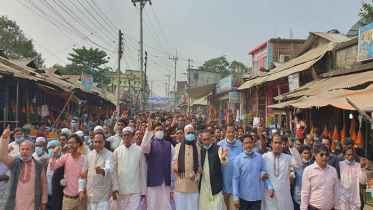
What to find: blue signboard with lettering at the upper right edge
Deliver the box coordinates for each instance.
[357,23,373,61]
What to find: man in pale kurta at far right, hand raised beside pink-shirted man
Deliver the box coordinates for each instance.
[339,146,367,210]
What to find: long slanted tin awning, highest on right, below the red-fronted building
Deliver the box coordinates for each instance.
[238,43,335,90]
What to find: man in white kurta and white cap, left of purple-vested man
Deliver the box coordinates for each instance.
[111,127,146,210]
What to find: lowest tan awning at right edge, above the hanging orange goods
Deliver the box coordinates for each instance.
[290,85,373,110]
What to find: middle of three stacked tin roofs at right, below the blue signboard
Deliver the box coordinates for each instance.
[274,71,373,100]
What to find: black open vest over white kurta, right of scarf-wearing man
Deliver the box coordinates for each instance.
[199,143,223,195]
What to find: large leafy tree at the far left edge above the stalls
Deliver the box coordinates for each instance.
[0,15,44,67]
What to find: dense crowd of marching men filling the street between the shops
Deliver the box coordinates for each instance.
[0,111,368,210]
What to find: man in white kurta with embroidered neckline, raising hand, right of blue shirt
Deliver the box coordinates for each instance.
[262,134,302,210]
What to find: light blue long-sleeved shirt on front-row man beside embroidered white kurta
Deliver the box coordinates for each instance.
[228,152,273,201]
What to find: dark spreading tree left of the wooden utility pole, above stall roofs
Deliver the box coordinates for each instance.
[53,47,110,85]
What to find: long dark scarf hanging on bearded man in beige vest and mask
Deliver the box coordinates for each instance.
[177,139,198,179]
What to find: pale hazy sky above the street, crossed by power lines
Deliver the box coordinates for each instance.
[0,0,362,96]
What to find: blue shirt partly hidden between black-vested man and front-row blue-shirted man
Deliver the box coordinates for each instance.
[218,139,243,194]
